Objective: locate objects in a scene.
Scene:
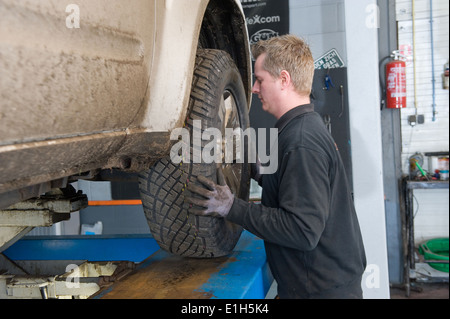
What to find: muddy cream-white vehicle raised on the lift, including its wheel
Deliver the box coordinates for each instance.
[0,0,252,258]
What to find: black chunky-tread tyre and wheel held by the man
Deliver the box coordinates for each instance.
[139,49,250,258]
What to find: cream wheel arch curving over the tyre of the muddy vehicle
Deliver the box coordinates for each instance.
[139,0,252,133]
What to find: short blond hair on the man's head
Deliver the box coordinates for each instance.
[252,35,314,95]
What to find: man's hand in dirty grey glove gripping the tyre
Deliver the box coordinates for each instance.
[186,168,234,218]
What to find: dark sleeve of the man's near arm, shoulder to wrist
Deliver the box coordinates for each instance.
[227,147,330,251]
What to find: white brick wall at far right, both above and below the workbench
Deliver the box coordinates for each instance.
[396,0,449,243]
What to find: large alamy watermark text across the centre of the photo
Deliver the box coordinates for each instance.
[170,120,278,175]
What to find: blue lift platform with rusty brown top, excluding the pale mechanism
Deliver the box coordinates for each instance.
[3,231,273,299]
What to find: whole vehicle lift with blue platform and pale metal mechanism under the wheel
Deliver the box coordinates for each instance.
[0,231,273,299]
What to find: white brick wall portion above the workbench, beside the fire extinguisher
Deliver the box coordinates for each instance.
[396,0,449,170]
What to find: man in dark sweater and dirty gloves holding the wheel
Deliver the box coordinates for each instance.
[186,35,366,299]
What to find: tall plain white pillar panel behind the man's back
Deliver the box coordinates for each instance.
[345,0,389,299]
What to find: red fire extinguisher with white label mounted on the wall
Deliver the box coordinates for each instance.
[386,51,406,109]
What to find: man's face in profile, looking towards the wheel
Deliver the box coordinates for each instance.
[252,54,281,119]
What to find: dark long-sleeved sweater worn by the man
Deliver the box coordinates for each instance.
[227,104,366,298]
